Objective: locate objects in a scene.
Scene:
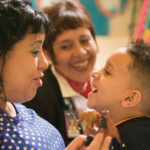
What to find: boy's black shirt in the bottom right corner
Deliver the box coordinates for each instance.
[110,116,150,150]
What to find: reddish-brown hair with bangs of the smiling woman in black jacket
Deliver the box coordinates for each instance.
[43,0,95,63]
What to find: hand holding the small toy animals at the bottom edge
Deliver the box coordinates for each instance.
[65,131,112,150]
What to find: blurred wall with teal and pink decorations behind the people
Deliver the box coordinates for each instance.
[31,0,150,68]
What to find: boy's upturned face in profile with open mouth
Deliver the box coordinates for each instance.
[88,48,132,112]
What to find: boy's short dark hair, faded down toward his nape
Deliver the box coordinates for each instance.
[127,39,150,112]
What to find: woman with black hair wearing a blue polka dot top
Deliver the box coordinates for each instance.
[0,0,64,150]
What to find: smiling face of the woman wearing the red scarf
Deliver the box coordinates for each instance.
[53,28,97,82]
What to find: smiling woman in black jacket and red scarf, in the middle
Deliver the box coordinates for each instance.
[25,0,98,145]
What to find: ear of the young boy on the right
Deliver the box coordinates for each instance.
[121,90,142,107]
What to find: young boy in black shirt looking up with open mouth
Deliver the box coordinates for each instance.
[88,40,150,150]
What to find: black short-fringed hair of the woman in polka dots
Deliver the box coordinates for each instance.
[0,0,50,97]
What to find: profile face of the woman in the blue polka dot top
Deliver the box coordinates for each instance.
[3,33,48,102]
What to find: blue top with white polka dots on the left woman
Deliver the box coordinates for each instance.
[0,104,65,150]
